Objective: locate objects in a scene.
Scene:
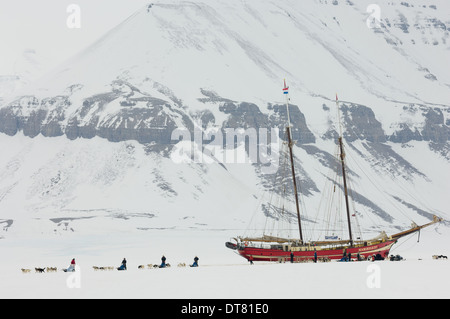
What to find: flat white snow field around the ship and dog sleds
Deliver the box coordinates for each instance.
[0,228,450,299]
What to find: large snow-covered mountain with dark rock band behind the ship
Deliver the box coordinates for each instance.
[0,0,450,240]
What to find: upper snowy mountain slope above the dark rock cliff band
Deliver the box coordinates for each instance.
[6,1,450,120]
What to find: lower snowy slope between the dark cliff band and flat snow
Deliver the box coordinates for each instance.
[0,129,450,239]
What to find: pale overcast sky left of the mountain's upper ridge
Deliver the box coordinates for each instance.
[0,0,152,75]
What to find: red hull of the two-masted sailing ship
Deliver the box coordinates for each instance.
[236,240,396,262]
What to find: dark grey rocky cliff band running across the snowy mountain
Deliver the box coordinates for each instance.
[0,91,450,144]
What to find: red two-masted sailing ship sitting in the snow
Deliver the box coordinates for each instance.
[225,81,442,262]
